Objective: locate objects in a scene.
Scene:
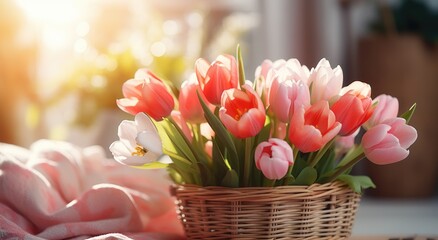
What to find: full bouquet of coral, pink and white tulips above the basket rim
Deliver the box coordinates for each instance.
[110,48,417,192]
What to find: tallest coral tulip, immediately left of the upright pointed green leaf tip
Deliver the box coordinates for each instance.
[195,55,239,105]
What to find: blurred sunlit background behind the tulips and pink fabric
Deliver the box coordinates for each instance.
[0,0,438,232]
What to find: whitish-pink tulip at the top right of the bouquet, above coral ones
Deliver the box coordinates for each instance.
[308,58,343,104]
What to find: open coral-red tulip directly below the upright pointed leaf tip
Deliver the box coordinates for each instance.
[219,84,266,138]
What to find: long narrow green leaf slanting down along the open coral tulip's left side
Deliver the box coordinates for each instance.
[197,92,239,172]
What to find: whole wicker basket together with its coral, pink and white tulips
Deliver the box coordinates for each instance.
[110,47,417,239]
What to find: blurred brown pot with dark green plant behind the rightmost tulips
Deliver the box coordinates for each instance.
[357,0,438,198]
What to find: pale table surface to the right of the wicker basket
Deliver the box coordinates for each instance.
[351,196,438,237]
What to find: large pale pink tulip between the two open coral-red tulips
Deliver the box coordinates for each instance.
[269,78,310,123]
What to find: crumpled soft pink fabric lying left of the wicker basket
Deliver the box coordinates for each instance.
[0,140,184,239]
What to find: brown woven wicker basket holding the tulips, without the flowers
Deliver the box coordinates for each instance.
[173,182,360,239]
